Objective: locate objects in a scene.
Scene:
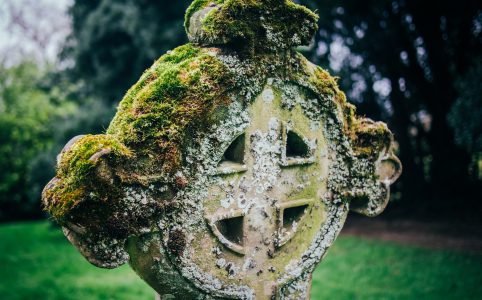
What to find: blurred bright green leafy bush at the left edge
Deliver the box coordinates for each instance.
[0,62,75,221]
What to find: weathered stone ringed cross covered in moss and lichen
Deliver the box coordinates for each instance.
[43,0,401,299]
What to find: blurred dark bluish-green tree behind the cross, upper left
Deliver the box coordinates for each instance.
[63,0,191,104]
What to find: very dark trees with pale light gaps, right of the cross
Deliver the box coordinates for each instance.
[301,0,482,216]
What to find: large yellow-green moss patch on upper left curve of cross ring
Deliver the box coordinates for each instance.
[107,44,232,172]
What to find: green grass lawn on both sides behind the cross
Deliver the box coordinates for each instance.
[0,222,482,300]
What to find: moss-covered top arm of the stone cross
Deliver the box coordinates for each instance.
[185,0,318,52]
